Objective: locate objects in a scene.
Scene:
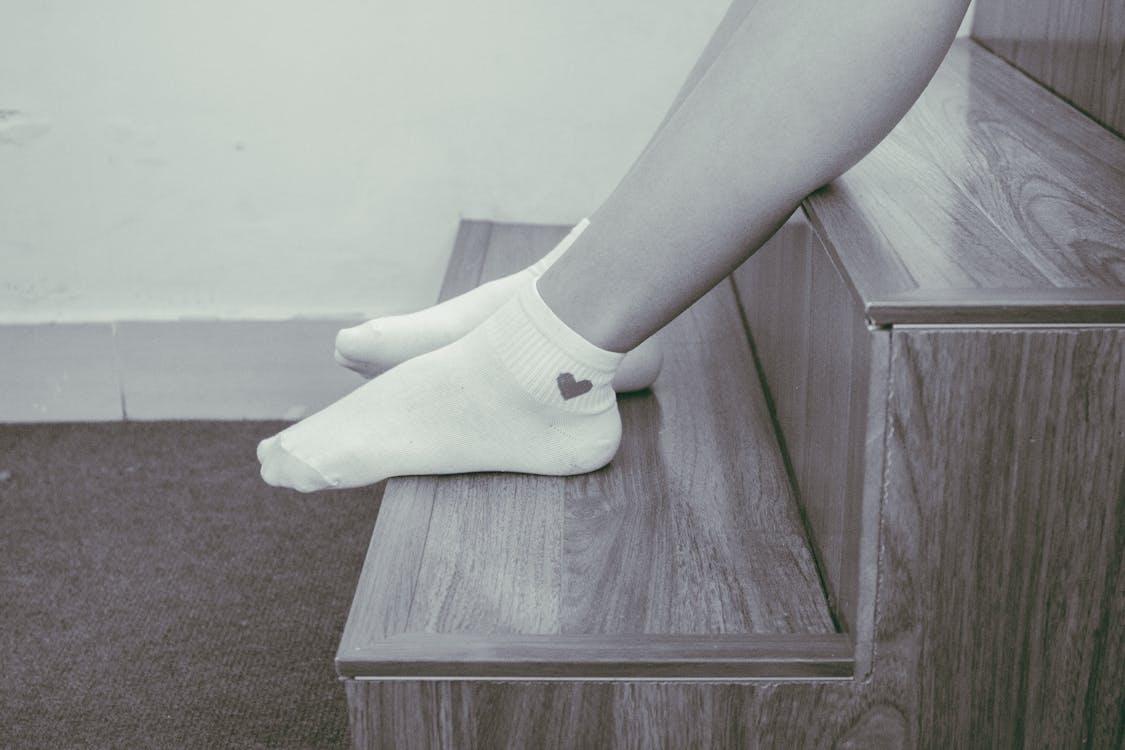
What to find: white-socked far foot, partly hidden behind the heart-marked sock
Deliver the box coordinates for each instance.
[335,219,664,392]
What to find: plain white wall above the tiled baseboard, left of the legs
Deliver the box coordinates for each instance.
[0,0,726,322]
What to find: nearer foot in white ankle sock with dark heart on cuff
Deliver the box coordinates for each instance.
[258,282,624,493]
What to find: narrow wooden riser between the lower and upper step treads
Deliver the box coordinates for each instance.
[735,216,889,650]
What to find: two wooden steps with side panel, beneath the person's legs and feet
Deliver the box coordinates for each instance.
[336,11,1125,748]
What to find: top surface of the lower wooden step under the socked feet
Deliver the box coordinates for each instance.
[338,222,846,672]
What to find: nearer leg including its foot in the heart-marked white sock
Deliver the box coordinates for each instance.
[259,0,969,490]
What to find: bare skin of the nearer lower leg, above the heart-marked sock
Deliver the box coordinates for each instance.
[539,0,969,351]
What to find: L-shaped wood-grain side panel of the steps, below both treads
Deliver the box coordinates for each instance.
[348,327,1125,748]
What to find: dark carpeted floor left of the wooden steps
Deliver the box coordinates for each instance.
[0,422,381,750]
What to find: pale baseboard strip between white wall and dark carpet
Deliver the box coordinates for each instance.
[0,320,363,423]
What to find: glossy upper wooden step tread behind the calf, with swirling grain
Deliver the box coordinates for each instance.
[804,39,1125,325]
